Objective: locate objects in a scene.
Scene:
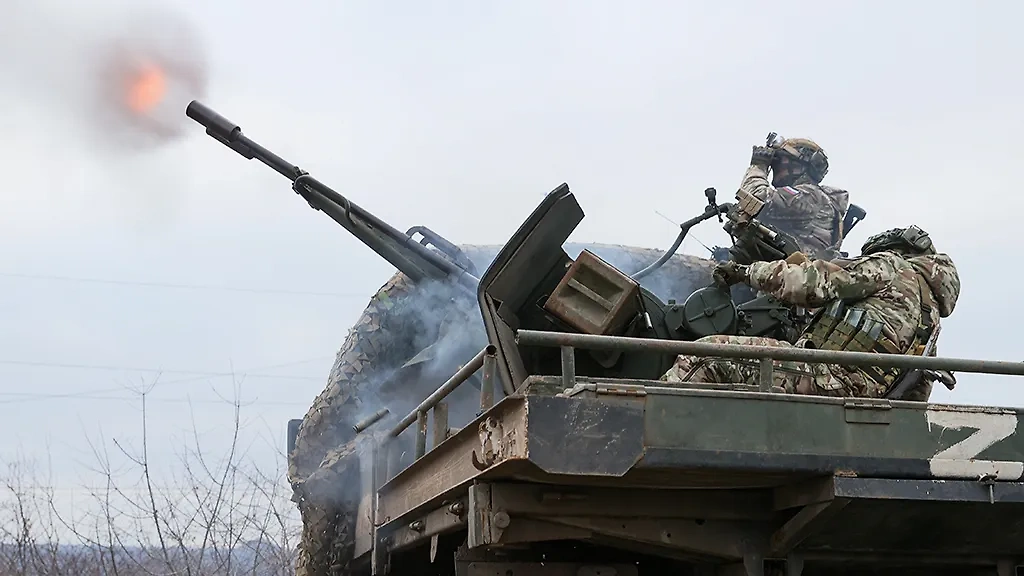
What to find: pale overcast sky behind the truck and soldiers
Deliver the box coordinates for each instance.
[0,0,1024,516]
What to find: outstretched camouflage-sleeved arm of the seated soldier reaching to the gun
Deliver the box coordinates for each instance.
[744,257,896,307]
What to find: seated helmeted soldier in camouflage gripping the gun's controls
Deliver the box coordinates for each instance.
[662,227,961,402]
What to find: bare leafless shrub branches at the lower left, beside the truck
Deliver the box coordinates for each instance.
[0,373,301,576]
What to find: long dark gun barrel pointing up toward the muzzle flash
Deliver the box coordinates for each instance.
[185,100,479,296]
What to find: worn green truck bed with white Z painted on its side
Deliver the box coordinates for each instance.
[356,376,1024,574]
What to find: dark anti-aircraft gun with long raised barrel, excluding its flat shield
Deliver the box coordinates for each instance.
[186,101,831,385]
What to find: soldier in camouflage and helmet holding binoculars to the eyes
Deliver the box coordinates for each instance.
[739,138,850,259]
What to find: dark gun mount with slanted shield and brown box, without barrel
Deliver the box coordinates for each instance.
[458,183,815,385]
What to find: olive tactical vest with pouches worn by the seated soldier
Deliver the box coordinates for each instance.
[799,274,939,392]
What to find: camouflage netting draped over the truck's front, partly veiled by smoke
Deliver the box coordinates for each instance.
[289,244,714,576]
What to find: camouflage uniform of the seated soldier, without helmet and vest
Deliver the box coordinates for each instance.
[662,228,959,401]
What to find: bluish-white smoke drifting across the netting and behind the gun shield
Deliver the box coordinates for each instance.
[303,239,711,498]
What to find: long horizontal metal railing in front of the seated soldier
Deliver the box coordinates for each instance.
[516,330,1024,392]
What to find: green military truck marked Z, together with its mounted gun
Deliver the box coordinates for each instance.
[189,102,1024,576]
